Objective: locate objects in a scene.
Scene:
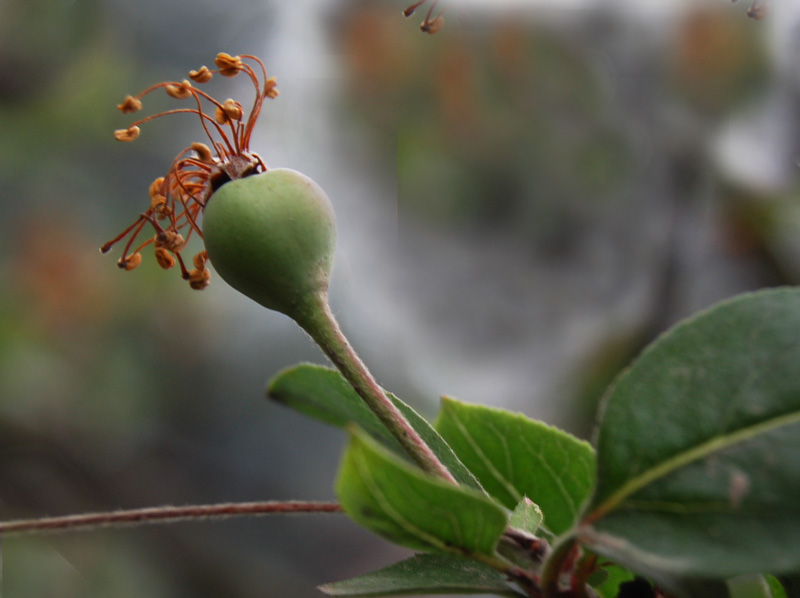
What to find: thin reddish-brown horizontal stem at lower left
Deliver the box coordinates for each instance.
[0,501,342,536]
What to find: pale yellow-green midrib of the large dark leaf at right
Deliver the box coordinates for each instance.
[584,411,800,523]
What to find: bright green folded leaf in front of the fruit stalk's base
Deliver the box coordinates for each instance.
[336,427,508,556]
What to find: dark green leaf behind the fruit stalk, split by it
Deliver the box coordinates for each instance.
[267,364,482,490]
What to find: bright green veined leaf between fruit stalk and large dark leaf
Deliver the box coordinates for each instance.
[435,397,595,534]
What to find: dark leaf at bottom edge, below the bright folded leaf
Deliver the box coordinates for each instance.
[319,554,523,598]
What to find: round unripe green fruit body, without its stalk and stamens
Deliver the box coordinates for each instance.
[203,168,336,319]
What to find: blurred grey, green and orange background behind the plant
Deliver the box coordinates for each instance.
[0,0,800,598]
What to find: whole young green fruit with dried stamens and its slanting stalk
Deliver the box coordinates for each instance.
[101,53,456,484]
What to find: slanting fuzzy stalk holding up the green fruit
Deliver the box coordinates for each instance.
[293,292,458,485]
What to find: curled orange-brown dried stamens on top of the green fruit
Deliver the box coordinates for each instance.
[101,52,278,289]
